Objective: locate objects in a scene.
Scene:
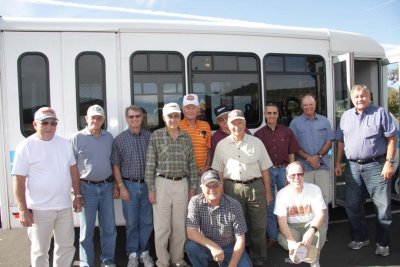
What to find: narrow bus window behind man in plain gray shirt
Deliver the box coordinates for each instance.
[76,52,107,130]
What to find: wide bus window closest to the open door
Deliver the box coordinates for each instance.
[264,54,327,125]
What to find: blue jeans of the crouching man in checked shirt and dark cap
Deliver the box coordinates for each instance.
[186,240,253,267]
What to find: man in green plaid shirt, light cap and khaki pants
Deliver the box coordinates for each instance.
[145,103,197,267]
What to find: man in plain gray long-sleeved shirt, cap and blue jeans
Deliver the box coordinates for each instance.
[71,105,116,267]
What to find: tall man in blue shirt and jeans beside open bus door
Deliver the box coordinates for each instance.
[335,85,398,256]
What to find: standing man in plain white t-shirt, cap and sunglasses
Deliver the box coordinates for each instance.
[12,107,83,267]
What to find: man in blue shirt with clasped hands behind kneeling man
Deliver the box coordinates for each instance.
[289,94,334,226]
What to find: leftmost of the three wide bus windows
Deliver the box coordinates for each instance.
[131,51,185,130]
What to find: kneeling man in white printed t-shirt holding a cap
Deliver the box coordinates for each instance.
[274,161,327,267]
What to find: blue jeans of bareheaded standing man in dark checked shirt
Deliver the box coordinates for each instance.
[122,180,153,256]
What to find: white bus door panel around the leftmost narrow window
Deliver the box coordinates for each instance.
[1,31,64,229]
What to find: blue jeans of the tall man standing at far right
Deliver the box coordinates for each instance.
[345,159,392,246]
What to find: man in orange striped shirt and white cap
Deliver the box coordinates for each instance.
[179,94,211,191]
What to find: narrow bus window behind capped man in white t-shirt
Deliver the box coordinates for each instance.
[18,53,50,137]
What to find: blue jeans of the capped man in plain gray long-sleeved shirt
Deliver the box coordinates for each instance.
[79,182,117,267]
